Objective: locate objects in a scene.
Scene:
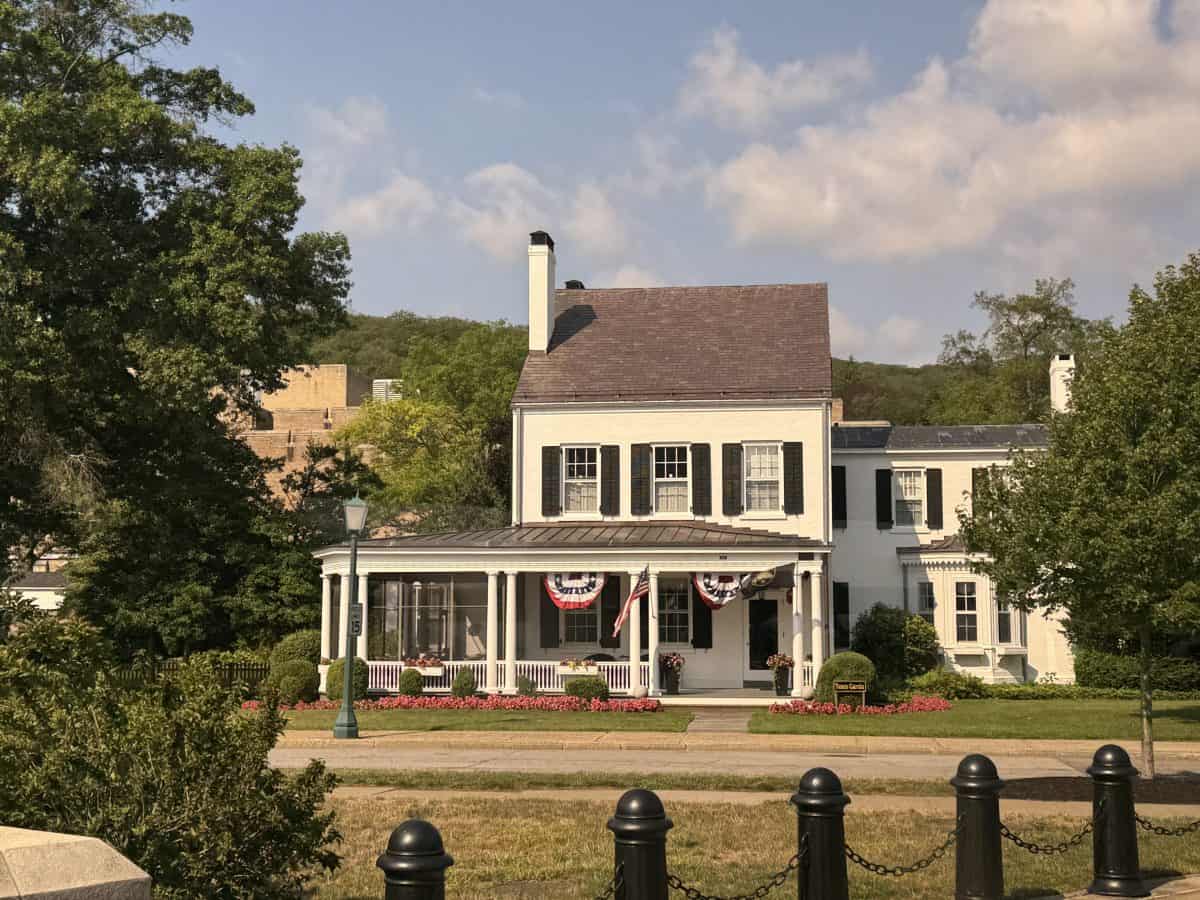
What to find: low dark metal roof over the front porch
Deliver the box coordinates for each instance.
[343,521,823,550]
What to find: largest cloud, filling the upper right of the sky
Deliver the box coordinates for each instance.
[708,0,1200,266]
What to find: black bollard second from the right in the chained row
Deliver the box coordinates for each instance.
[950,754,1004,900]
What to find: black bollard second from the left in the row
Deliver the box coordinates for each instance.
[608,790,673,900]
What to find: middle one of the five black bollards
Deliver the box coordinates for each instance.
[792,768,850,900]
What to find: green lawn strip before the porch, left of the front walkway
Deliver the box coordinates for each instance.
[287,709,691,731]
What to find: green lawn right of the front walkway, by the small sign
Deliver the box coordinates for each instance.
[750,700,1200,740]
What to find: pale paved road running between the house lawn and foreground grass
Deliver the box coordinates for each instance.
[271,745,1152,779]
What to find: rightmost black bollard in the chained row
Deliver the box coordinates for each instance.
[1087,744,1150,896]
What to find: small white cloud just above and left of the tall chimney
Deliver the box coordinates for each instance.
[450,162,558,263]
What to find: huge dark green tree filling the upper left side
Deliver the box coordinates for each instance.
[0,0,349,652]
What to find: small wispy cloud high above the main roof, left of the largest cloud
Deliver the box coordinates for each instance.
[679,26,871,128]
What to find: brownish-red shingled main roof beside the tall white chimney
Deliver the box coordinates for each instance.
[512,284,832,403]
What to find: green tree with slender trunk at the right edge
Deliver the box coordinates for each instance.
[960,254,1200,776]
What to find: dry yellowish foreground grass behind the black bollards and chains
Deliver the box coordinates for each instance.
[310,796,1200,900]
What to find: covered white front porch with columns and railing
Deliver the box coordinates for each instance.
[318,522,828,696]
